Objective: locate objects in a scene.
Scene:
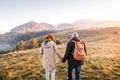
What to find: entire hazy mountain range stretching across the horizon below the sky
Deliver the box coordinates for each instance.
[0,19,120,50]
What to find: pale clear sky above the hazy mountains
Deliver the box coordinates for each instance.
[0,0,120,33]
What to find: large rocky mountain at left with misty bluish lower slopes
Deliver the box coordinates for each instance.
[0,21,56,51]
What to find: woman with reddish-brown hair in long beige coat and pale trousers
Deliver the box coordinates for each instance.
[40,34,62,80]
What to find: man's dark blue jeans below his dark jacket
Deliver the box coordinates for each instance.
[68,66,81,80]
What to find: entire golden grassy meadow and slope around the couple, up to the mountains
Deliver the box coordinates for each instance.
[0,28,120,80]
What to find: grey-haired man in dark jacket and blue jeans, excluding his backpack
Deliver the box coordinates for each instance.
[62,32,87,80]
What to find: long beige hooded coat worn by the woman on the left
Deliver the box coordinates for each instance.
[40,41,61,70]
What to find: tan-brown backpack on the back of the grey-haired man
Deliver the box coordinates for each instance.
[72,40,85,63]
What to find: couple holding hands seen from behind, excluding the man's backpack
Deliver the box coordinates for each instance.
[40,32,87,80]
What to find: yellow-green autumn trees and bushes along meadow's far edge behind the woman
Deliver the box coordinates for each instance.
[0,38,62,54]
